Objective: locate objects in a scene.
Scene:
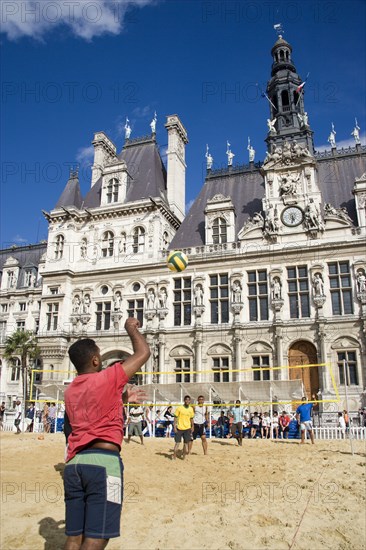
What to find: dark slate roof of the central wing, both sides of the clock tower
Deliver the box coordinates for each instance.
[169,150,366,249]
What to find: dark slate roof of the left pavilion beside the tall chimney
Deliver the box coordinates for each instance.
[83,138,167,208]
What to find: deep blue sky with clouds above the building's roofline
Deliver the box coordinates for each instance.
[0,0,366,248]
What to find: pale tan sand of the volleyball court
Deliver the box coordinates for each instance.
[0,433,366,550]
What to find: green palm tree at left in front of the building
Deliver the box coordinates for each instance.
[4,329,40,406]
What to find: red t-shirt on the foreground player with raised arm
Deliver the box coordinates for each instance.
[65,363,128,462]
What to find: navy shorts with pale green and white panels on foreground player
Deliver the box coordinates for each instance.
[64,449,123,539]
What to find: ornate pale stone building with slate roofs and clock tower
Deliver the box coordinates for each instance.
[0,37,366,410]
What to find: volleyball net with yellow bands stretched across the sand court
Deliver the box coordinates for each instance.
[31,363,341,411]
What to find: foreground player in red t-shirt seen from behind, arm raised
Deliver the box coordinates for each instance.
[64,317,150,550]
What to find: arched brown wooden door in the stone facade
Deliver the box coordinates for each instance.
[288,340,320,399]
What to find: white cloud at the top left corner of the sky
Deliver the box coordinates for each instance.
[0,0,157,40]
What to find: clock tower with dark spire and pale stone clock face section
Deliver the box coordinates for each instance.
[261,36,324,242]
